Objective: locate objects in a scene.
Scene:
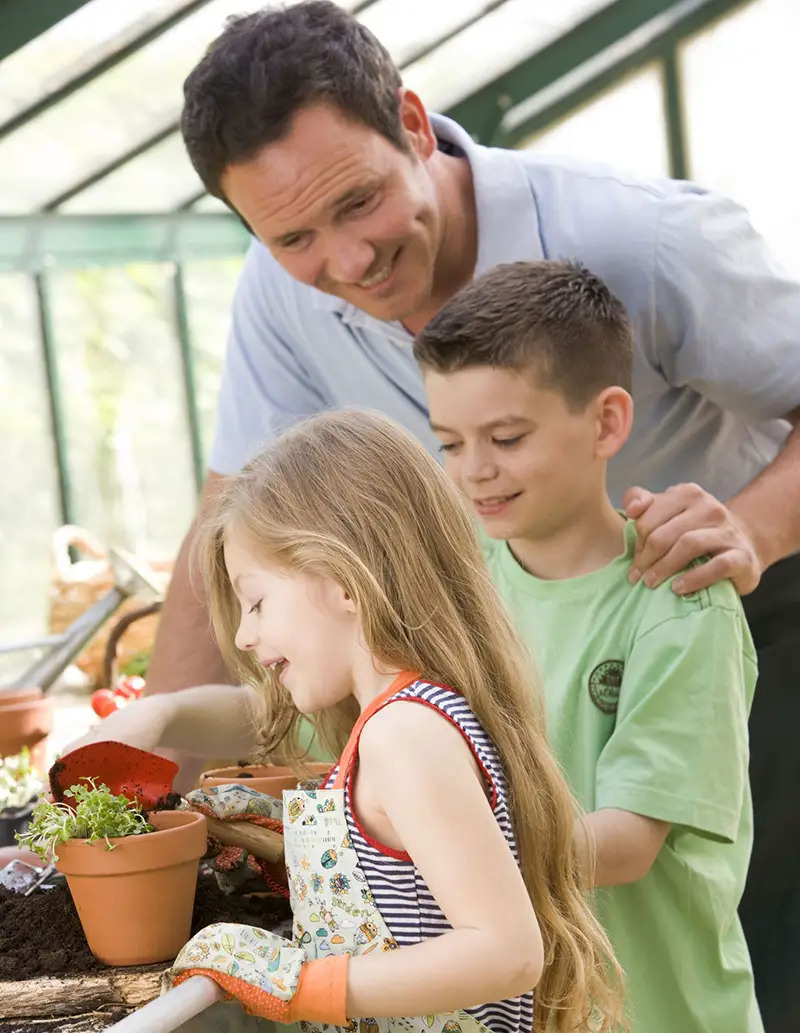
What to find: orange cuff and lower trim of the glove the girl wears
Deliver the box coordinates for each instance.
[173,954,350,1026]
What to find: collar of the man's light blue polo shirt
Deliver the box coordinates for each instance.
[310,114,544,332]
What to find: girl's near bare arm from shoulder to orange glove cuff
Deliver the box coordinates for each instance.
[347,702,544,1018]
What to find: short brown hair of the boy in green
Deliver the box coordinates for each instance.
[413,261,634,409]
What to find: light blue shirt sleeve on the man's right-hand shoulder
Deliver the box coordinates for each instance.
[654,193,800,420]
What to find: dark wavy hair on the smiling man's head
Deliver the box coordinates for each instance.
[181,0,408,199]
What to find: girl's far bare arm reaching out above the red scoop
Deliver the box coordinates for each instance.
[64,685,261,757]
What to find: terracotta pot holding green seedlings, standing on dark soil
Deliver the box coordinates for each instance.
[54,811,206,966]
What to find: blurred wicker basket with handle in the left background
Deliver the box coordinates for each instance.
[49,524,172,685]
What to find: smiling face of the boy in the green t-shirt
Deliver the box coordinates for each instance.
[424,366,605,540]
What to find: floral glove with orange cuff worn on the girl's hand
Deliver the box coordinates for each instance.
[161,922,349,1026]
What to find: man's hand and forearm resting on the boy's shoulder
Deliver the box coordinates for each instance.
[623,408,800,595]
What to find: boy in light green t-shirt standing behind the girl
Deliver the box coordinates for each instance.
[416,261,763,1033]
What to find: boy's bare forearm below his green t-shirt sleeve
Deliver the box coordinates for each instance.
[576,808,671,886]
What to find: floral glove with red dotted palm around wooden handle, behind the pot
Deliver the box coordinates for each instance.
[186,784,287,896]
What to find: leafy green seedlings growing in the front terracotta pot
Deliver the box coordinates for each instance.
[17,779,153,860]
